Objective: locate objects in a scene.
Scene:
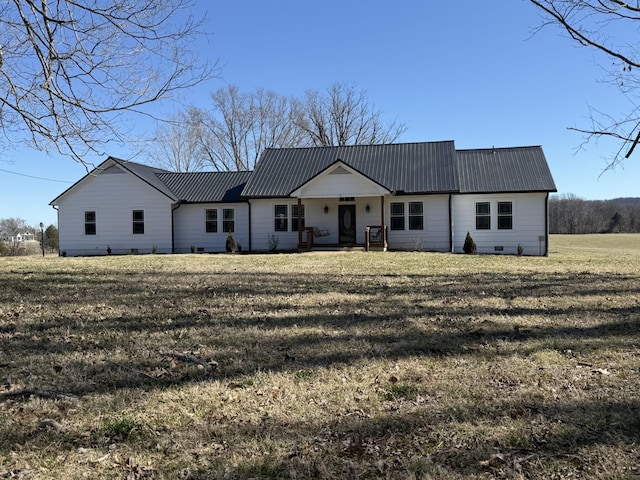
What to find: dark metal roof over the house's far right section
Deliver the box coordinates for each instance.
[456,146,557,193]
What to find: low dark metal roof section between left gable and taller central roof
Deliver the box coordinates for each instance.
[157,172,251,203]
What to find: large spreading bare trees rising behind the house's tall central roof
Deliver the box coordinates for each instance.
[159,83,406,171]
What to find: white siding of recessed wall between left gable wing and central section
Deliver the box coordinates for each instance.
[173,203,249,253]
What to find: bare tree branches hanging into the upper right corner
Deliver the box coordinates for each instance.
[531,0,640,168]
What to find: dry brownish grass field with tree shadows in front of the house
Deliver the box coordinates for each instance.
[0,235,640,480]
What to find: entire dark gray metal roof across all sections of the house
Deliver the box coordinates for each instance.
[51,141,557,205]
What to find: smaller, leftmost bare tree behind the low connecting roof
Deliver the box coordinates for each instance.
[149,112,206,172]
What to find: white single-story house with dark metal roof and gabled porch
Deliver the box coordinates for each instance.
[51,141,556,256]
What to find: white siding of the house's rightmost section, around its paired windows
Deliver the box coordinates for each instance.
[453,193,547,255]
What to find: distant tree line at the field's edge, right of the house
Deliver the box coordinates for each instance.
[549,194,640,234]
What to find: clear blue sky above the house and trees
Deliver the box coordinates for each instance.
[0,0,640,229]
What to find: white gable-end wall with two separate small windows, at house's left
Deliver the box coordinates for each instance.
[58,167,171,256]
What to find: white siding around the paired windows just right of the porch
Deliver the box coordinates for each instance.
[385,195,449,252]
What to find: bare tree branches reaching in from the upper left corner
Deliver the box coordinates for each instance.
[0,0,216,163]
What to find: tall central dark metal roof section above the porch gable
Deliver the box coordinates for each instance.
[242,141,458,197]
